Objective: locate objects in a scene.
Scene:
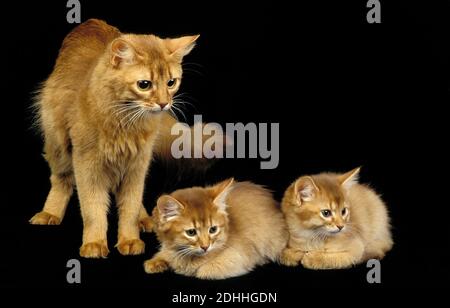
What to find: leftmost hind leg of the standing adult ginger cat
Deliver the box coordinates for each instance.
[30,140,75,225]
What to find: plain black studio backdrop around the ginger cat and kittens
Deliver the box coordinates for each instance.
[1,0,450,296]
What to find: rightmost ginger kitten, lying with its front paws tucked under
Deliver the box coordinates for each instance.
[281,168,393,269]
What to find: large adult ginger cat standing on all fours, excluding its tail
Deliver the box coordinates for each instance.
[30,19,198,258]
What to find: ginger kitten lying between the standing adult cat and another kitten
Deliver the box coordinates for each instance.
[144,179,288,279]
